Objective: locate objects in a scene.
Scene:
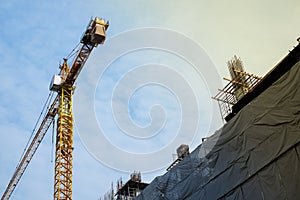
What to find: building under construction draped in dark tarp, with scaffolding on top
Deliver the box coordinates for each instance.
[136,39,300,200]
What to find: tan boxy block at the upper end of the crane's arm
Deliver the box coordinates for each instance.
[81,17,109,46]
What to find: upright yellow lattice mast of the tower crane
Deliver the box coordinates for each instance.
[54,85,73,200]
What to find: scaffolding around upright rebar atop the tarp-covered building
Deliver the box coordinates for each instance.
[212,56,262,119]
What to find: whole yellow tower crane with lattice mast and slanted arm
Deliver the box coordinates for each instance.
[1,17,109,200]
